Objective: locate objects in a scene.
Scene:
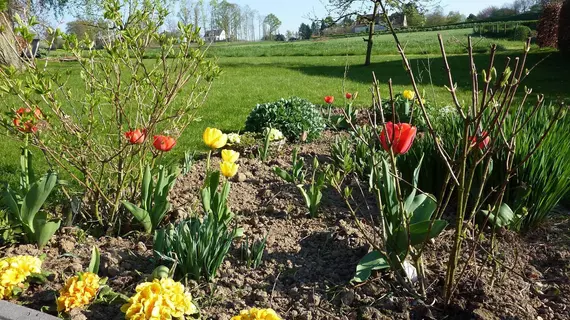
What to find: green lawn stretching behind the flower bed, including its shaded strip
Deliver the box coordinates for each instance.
[0,30,570,186]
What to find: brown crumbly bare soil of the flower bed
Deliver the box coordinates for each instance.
[0,132,570,320]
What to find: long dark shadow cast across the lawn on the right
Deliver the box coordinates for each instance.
[289,51,570,101]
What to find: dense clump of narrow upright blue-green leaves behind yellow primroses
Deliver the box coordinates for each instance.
[153,214,237,281]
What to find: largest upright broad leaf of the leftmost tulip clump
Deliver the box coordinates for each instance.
[21,172,57,232]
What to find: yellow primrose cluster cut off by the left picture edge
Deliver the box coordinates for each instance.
[0,256,42,299]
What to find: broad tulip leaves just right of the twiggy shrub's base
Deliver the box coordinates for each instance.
[121,165,180,233]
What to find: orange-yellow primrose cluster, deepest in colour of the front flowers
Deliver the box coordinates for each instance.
[57,272,100,312]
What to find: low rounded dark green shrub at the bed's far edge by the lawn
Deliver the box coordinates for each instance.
[245,97,325,141]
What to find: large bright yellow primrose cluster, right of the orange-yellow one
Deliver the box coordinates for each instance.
[121,278,198,320]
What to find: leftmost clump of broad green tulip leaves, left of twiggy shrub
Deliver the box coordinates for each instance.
[2,172,61,248]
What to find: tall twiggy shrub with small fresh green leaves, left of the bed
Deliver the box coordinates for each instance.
[0,0,220,233]
